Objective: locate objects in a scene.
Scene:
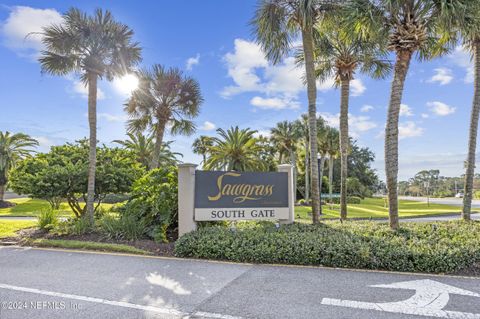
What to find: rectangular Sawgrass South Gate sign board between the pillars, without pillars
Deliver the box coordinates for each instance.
[195,171,289,221]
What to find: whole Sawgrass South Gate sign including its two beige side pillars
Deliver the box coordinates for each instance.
[178,163,295,236]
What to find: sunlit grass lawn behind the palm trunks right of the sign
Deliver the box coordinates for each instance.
[295,198,474,221]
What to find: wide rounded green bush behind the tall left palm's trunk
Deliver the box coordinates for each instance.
[11,140,144,217]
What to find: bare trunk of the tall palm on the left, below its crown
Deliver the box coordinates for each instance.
[85,72,97,225]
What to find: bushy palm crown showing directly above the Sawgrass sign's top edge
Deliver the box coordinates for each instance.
[205,126,265,172]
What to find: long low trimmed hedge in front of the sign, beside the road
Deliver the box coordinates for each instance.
[175,221,480,273]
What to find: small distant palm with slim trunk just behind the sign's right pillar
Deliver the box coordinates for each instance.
[270,121,300,202]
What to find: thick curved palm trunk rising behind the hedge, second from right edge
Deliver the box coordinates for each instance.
[385,51,412,230]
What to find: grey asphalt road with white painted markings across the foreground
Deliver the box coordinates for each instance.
[0,247,480,319]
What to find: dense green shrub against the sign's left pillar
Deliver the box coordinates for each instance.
[119,166,178,241]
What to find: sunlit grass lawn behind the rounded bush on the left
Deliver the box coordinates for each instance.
[0,198,112,216]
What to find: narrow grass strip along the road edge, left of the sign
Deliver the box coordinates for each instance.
[32,239,150,255]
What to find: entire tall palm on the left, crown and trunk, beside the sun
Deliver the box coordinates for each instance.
[39,8,141,224]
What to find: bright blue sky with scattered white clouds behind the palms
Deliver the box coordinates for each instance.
[0,0,480,180]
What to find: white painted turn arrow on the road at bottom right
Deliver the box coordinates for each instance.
[322,279,480,319]
